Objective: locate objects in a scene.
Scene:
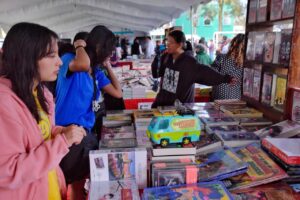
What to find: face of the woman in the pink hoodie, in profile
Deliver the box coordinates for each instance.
[38,40,62,81]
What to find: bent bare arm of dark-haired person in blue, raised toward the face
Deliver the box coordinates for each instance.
[103,60,123,98]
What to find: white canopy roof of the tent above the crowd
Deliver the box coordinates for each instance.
[0,0,207,35]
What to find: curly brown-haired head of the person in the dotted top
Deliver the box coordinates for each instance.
[227,33,245,66]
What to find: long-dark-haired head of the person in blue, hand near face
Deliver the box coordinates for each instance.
[86,25,116,67]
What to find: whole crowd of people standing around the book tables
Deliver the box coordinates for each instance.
[0,23,244,200]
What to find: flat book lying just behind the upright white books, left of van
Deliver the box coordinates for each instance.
[99,138,137,149]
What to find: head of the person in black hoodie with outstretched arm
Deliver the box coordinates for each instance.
[167,30,186,54]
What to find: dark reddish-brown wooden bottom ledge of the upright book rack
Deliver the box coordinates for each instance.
[242,96,284,123]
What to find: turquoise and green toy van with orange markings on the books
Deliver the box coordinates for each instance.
[147,115,201,147]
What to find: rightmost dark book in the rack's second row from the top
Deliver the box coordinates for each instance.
[279,29,292,66]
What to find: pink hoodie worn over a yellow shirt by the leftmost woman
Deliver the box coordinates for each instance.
[0,77,69,200]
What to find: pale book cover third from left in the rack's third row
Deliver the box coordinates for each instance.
[261,73,273,105]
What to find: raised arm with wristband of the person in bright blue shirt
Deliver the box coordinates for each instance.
[69,40,90,72]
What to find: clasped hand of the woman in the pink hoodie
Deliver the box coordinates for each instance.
[62,125,86,146]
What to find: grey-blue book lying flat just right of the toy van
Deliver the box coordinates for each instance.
[215,131,259,147]
